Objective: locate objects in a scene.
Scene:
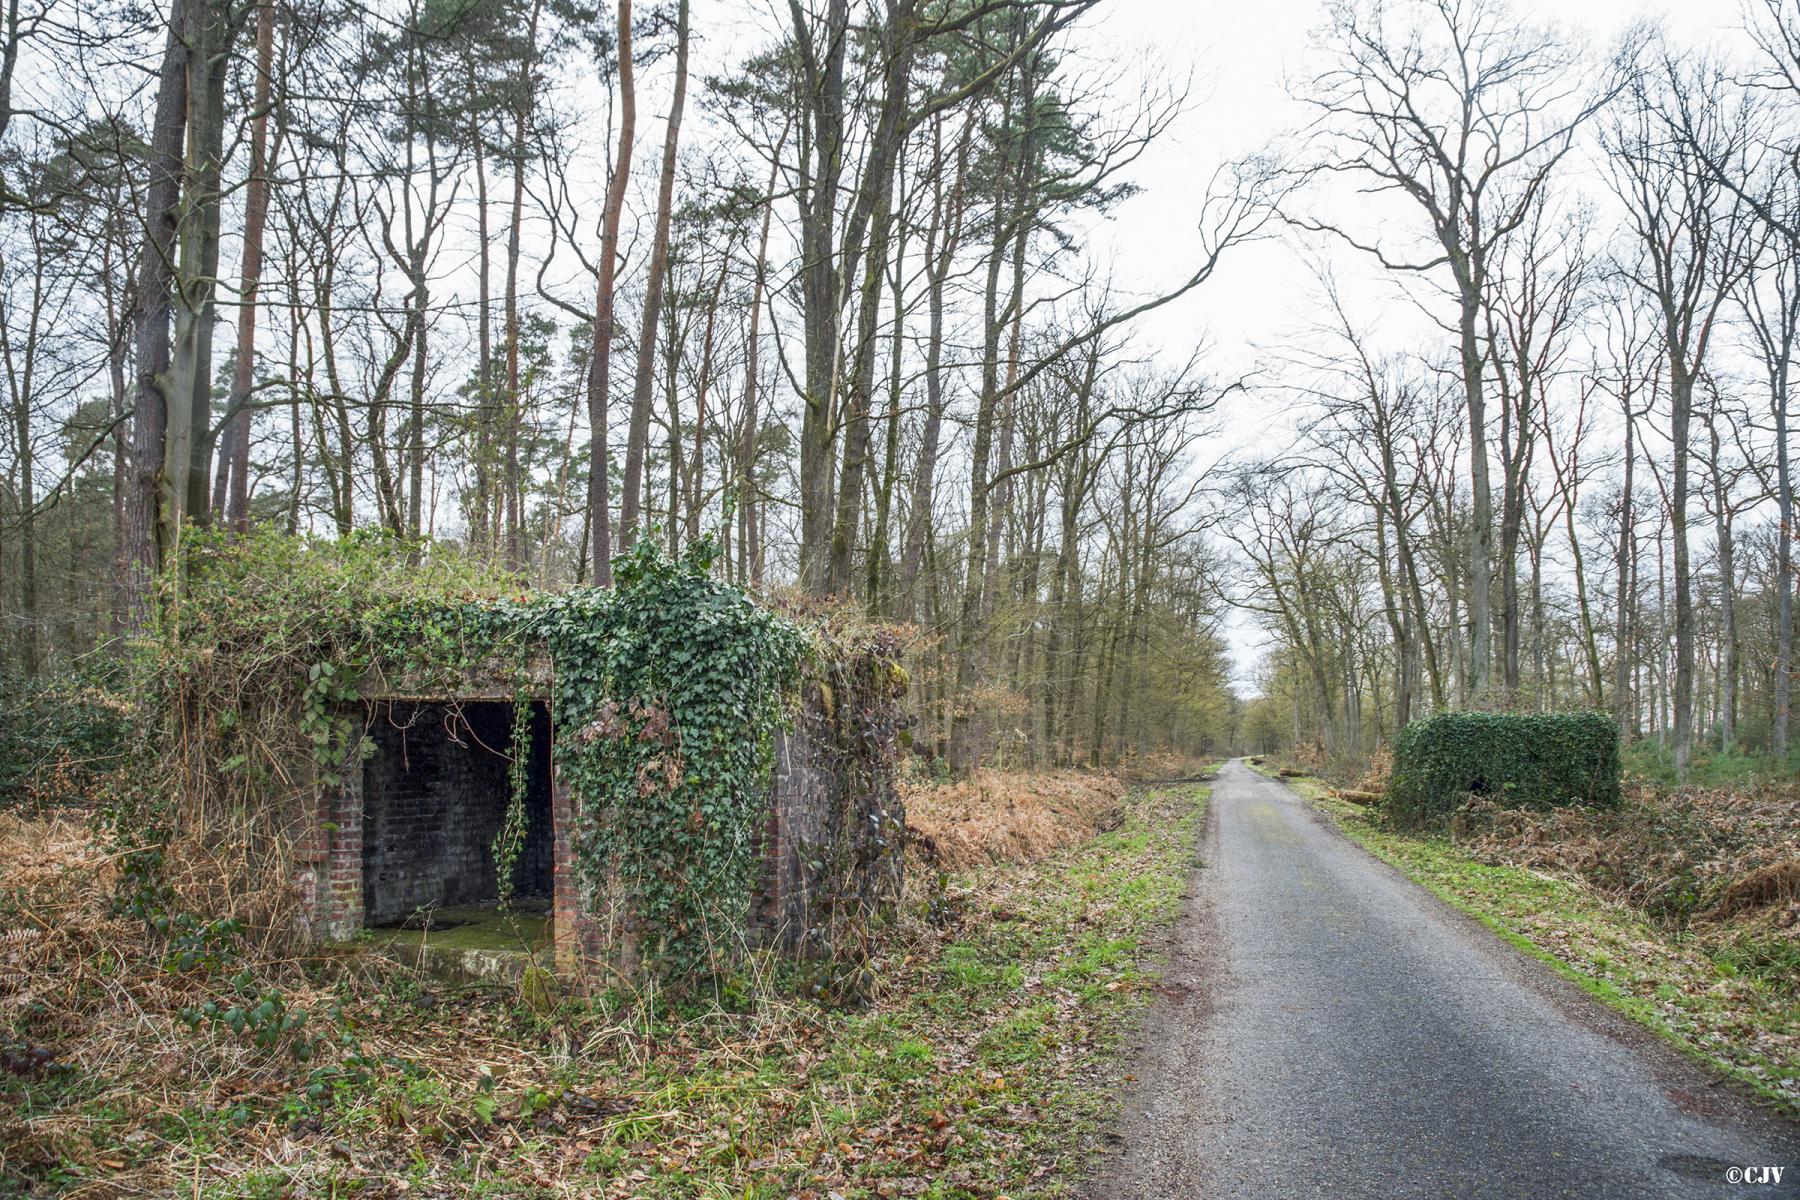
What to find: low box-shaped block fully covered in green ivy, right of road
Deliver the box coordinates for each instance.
[1388,712,1618,826]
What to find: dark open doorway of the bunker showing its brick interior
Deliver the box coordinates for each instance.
[362,702,553,925]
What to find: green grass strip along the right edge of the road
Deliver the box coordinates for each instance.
[1269,772,1800,1115]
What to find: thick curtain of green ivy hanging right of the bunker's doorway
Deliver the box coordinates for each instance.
[535,540,810,979]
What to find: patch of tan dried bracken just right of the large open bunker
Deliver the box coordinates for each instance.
[900,770,1125,871]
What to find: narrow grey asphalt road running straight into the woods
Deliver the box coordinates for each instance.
[1089,763,1800,1200]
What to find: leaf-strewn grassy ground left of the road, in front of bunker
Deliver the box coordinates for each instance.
[0,786,1206,1200]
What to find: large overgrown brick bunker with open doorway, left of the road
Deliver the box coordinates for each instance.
[156,536,905,977]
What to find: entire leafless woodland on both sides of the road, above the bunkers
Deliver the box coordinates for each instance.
[0,0,1800,780]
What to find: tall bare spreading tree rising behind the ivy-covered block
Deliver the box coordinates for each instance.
[1289,0,1606,694]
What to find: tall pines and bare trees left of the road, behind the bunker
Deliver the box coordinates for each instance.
[0,0,1269,763]
